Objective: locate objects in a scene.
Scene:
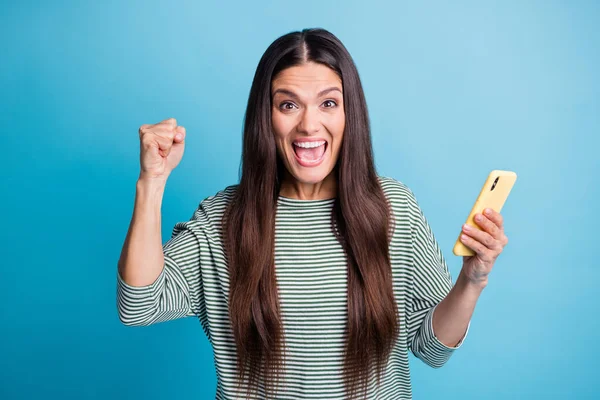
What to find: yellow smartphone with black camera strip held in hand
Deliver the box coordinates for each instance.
[452,170,517,256]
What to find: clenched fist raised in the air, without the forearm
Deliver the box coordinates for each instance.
[139,118,185,182]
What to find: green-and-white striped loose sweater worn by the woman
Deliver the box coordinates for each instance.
[117,177,468,400]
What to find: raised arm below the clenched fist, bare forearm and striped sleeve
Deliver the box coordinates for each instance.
[117,177,204,325]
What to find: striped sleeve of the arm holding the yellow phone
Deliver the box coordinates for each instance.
[406,192,470,368]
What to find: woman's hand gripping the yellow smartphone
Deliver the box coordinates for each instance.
[460,209,508,286]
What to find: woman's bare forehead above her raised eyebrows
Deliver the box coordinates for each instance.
[271,62,342,94]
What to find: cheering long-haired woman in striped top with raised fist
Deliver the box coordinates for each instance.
[117,29,507,399]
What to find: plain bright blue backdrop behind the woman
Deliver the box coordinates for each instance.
[0,1,600,399]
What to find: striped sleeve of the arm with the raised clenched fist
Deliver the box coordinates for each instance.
[117,205,209,325]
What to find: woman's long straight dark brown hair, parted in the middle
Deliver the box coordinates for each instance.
[223,29,398,398]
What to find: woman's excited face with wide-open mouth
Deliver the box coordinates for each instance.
[271,62,345,189]
